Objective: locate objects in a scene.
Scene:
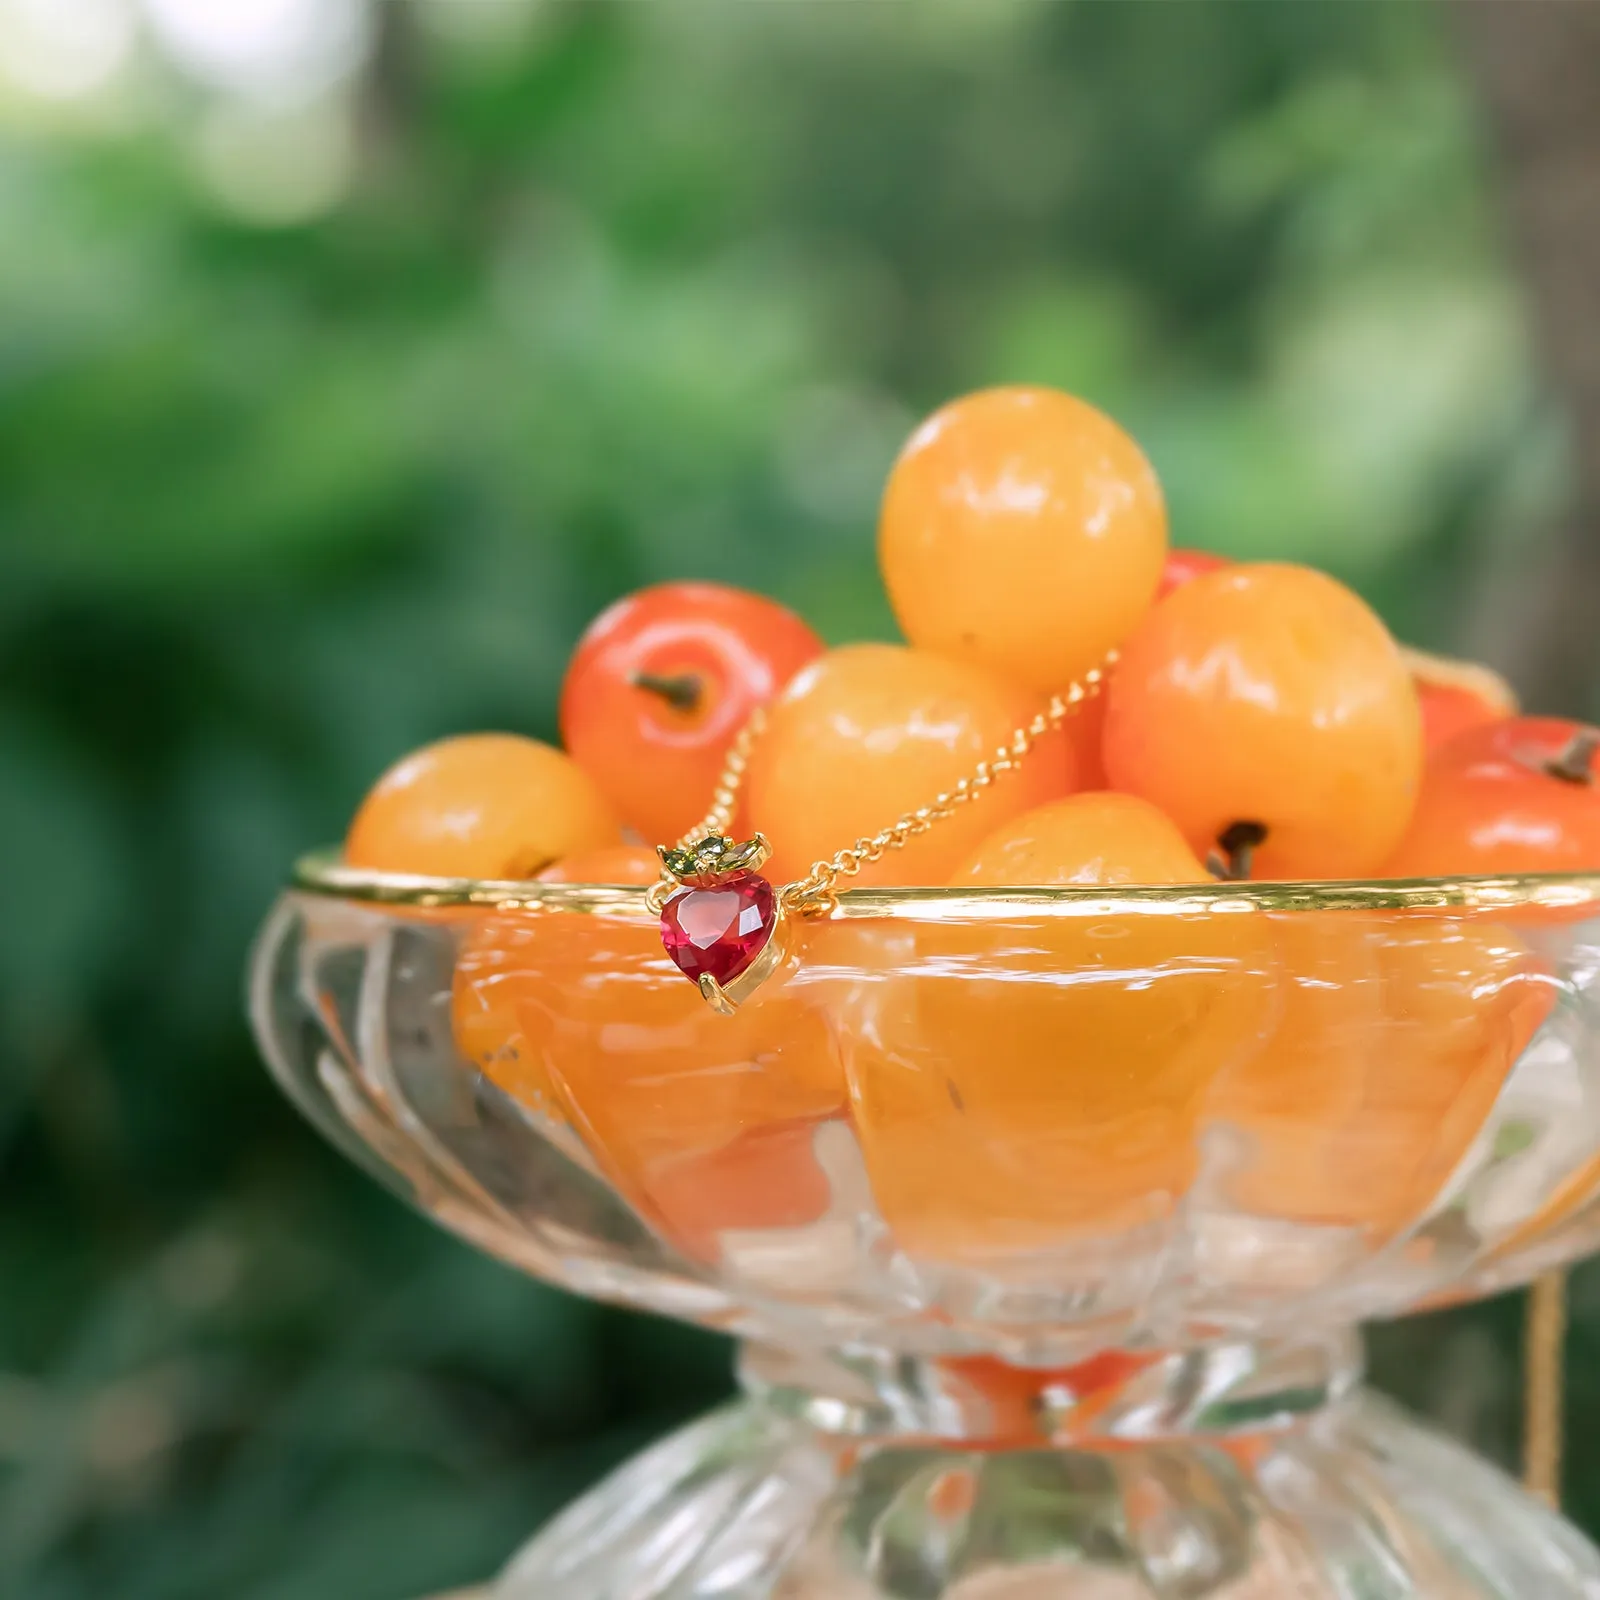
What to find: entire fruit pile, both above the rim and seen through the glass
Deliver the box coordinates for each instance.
[334,389,1600,1259]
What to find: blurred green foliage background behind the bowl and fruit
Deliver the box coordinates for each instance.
[0,0,1600,1600]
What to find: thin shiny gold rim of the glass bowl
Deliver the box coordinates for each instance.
[290,851,1600,922]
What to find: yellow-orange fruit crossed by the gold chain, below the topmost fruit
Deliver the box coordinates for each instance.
[747,645,1072,885]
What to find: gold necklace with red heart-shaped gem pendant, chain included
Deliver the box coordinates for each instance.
[650,651,1117,1016]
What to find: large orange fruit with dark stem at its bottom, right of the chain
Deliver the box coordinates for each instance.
[1104,563,1422,878]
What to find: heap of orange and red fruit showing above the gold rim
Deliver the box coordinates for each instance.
[346,389,1600,885]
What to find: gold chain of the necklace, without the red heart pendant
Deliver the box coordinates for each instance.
[661,651,1117,917]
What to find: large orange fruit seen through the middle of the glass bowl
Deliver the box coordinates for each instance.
[840,908,1272,1254]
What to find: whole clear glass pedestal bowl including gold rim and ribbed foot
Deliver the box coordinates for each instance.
[240,861,1600,1600]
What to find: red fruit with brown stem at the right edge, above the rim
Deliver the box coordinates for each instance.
[1386,717,1600,878]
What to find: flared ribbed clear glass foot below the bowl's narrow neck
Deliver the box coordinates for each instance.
[490,1344,1600,1600]
